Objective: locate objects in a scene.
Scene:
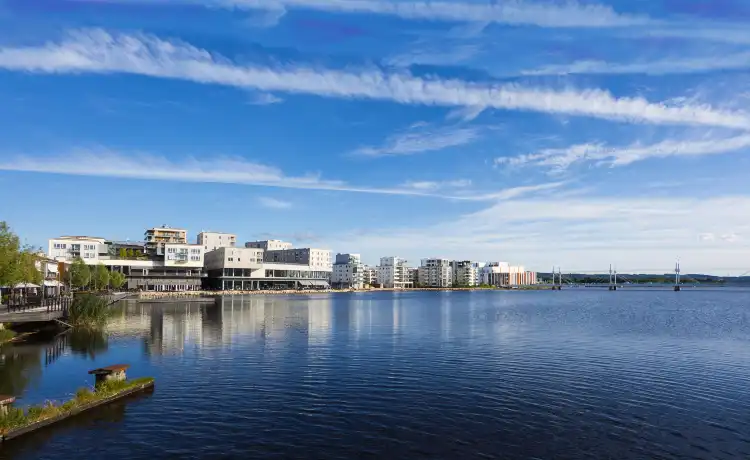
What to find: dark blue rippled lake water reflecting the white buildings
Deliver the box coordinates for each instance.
[0,289,750,460]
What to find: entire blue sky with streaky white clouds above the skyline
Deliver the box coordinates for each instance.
[0,0,750,274]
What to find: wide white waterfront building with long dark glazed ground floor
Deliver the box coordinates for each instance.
[204,248,331,290]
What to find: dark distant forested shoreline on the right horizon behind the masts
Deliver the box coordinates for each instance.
[537,273,750,286]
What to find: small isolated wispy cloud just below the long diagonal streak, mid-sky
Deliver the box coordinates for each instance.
[354,126,479,157]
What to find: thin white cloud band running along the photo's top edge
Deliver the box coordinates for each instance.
[117,0,653,27]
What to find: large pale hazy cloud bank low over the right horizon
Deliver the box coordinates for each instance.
[331,196,750,274]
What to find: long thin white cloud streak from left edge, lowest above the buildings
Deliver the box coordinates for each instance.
[0,149,561,201]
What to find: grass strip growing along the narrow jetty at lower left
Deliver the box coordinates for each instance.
[0,377,154,435]
